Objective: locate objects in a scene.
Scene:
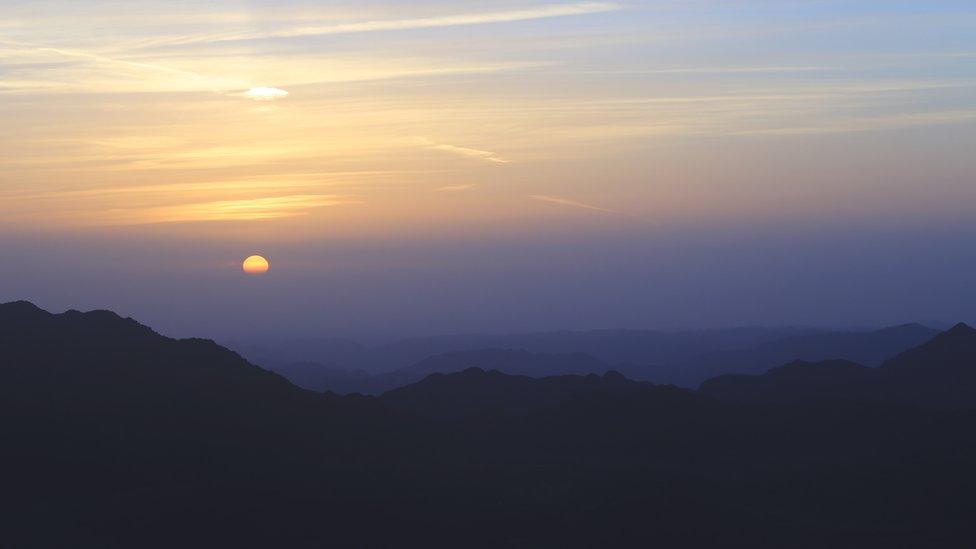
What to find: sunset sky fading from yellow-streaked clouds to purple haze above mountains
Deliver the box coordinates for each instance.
[0,0,976,339]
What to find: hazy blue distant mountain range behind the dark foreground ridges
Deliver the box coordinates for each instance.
[248,324,939,394]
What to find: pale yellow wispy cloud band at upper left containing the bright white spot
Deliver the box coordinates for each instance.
[0,40,550,96]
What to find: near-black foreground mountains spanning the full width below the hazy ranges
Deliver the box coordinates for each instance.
[0,302,976,548]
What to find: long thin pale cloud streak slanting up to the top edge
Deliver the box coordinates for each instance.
[144,2,620,46]
